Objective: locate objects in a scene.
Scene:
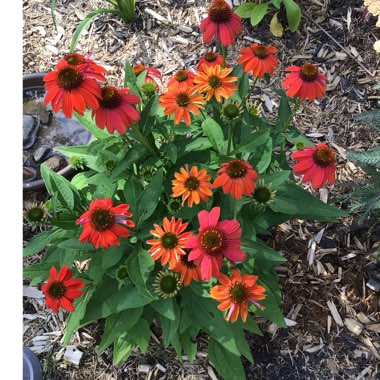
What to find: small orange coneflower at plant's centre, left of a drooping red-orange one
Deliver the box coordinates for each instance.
[172,165,212,207]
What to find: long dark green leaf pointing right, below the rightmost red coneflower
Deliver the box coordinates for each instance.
[269,181,348,222]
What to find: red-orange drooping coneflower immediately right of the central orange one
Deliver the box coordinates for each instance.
[213,160,259,199]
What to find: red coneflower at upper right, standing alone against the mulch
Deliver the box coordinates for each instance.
[281,63,327,101]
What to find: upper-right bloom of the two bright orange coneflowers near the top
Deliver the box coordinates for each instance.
[194,65,238,102]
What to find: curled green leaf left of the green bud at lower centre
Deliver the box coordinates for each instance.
[125,249,154,298]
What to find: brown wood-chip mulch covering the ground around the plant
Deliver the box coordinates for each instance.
[23,0,380,380]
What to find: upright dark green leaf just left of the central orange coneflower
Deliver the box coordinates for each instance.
[135,169,163,222]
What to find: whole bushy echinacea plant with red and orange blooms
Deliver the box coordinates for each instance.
[24,0,346,379]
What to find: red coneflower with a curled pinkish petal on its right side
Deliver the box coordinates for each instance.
[76,198,135,249]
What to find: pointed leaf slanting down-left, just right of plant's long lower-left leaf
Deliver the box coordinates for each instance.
[97,307,144,353]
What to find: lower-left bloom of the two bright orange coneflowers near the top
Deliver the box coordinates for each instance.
[160,85,206,125]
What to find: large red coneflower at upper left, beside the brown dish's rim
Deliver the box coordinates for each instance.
[43,60,101,118]
